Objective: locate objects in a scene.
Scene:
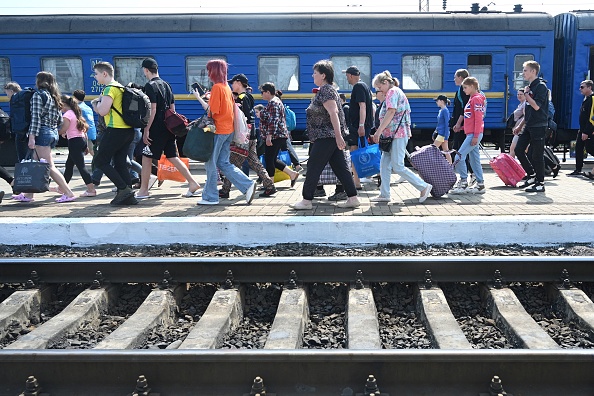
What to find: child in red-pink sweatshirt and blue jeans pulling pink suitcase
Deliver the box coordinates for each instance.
[450,77,485,194]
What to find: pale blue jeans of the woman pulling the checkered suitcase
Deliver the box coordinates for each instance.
[380,137,428,198]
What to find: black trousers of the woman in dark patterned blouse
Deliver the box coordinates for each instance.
[302,138,357,201]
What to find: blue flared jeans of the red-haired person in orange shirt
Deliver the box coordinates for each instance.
[202,133,253,202]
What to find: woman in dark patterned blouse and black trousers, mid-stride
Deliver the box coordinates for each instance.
[291,59,361,210]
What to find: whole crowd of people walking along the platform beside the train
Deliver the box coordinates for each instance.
[0,58,594,210]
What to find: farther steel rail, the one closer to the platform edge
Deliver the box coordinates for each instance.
[0,256,594,283]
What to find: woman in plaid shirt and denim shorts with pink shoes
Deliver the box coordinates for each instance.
[12,71,76,203]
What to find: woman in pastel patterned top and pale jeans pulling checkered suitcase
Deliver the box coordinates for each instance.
[370,70,433,203]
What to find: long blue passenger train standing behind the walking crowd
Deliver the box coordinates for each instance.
[0,11,594,151]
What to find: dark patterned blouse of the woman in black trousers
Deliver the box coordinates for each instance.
[305,84,346,142]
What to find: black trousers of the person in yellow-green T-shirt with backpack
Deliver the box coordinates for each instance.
[93,128,134,190]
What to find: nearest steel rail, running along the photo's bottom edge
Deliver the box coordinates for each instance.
[0,350,594,396]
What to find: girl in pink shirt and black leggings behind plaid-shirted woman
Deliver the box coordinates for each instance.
[56,95,97,197]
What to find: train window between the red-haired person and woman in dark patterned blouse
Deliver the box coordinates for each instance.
[258,56,299,91]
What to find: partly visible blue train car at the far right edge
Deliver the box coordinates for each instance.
[552,11,594,144]
